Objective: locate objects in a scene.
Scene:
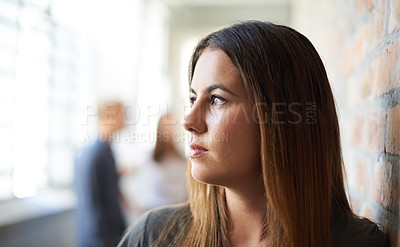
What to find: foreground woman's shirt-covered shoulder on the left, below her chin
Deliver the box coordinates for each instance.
[118,204,189,247]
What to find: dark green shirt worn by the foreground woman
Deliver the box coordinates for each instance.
[118,205,389,247]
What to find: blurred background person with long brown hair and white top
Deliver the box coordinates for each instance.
[121,114,188,220]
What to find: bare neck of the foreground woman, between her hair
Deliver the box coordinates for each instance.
[225,180,266,247]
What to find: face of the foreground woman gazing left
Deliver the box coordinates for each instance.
[184,48,261,187]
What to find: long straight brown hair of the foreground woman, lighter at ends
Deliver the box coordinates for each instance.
[160,21,352,247]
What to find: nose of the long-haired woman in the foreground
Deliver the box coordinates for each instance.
[183,105,207,134]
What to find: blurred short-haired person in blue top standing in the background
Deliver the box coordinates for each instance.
[75,101,125,247]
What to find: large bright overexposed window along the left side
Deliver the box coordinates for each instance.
[0,0,94,200]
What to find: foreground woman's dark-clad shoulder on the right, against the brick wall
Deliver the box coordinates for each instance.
[332,216,390,247]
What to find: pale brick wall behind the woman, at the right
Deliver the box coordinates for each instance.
[292,0,400,246]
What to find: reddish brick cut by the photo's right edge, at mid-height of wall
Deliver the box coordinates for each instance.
[386,105,400,155]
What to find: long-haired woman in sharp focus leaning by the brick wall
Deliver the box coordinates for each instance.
[120,21,387,247]
